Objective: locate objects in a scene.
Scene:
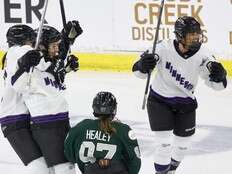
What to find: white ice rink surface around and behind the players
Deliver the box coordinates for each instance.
[0,71,232,174]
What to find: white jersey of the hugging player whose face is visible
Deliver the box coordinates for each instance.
[13,59,68,117]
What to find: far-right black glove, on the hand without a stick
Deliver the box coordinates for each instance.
[207,61,227,83]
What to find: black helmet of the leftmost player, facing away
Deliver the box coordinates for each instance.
[6,25,36,47]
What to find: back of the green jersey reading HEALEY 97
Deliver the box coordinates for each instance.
[66,119,136,163]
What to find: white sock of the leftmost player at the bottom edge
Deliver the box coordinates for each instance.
[27,157,49,174]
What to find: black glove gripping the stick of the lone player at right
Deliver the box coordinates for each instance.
[138,51,159,73]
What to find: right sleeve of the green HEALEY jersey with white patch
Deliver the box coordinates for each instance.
[123,126,141,174]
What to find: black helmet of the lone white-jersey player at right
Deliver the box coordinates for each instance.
[174,16,203,49]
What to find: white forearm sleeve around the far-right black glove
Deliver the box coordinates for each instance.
[200,56,225,90]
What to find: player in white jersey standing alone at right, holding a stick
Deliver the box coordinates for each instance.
[133,16,227,174]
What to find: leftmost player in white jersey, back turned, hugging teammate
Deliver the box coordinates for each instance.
[0,25,49,173]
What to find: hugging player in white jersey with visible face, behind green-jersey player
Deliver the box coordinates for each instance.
[21,22,82,174]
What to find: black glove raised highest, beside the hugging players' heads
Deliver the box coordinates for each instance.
[62,21,83,44]
